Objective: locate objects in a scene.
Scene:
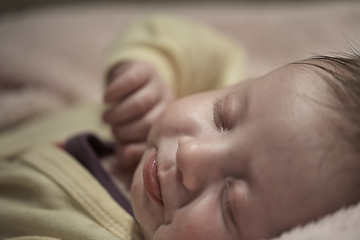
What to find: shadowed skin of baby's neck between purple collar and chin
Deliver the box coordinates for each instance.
[100,155,133,201]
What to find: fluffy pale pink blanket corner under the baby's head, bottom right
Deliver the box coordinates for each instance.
[272,202,360,240]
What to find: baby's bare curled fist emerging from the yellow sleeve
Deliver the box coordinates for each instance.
[103,62,175,169]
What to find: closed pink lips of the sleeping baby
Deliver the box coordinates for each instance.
[143,149,164,206]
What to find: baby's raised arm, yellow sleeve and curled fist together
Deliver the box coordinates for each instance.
[105,16,245,169]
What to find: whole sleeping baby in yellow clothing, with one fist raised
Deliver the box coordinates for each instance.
[0,16,360,240]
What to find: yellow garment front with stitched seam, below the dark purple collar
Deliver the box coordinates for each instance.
[0,144,143,240]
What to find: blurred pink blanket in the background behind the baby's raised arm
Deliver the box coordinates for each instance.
[0,2,360,129]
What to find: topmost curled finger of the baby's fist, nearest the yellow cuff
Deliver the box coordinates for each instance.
[104,62,152,103]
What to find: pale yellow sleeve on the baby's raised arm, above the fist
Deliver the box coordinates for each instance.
[106,16,245,97]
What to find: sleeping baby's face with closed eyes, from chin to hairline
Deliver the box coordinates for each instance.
[131,63,354,240]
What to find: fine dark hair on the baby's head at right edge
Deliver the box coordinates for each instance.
[294,48,360,154]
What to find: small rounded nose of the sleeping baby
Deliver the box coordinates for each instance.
[176,137,226,191]
